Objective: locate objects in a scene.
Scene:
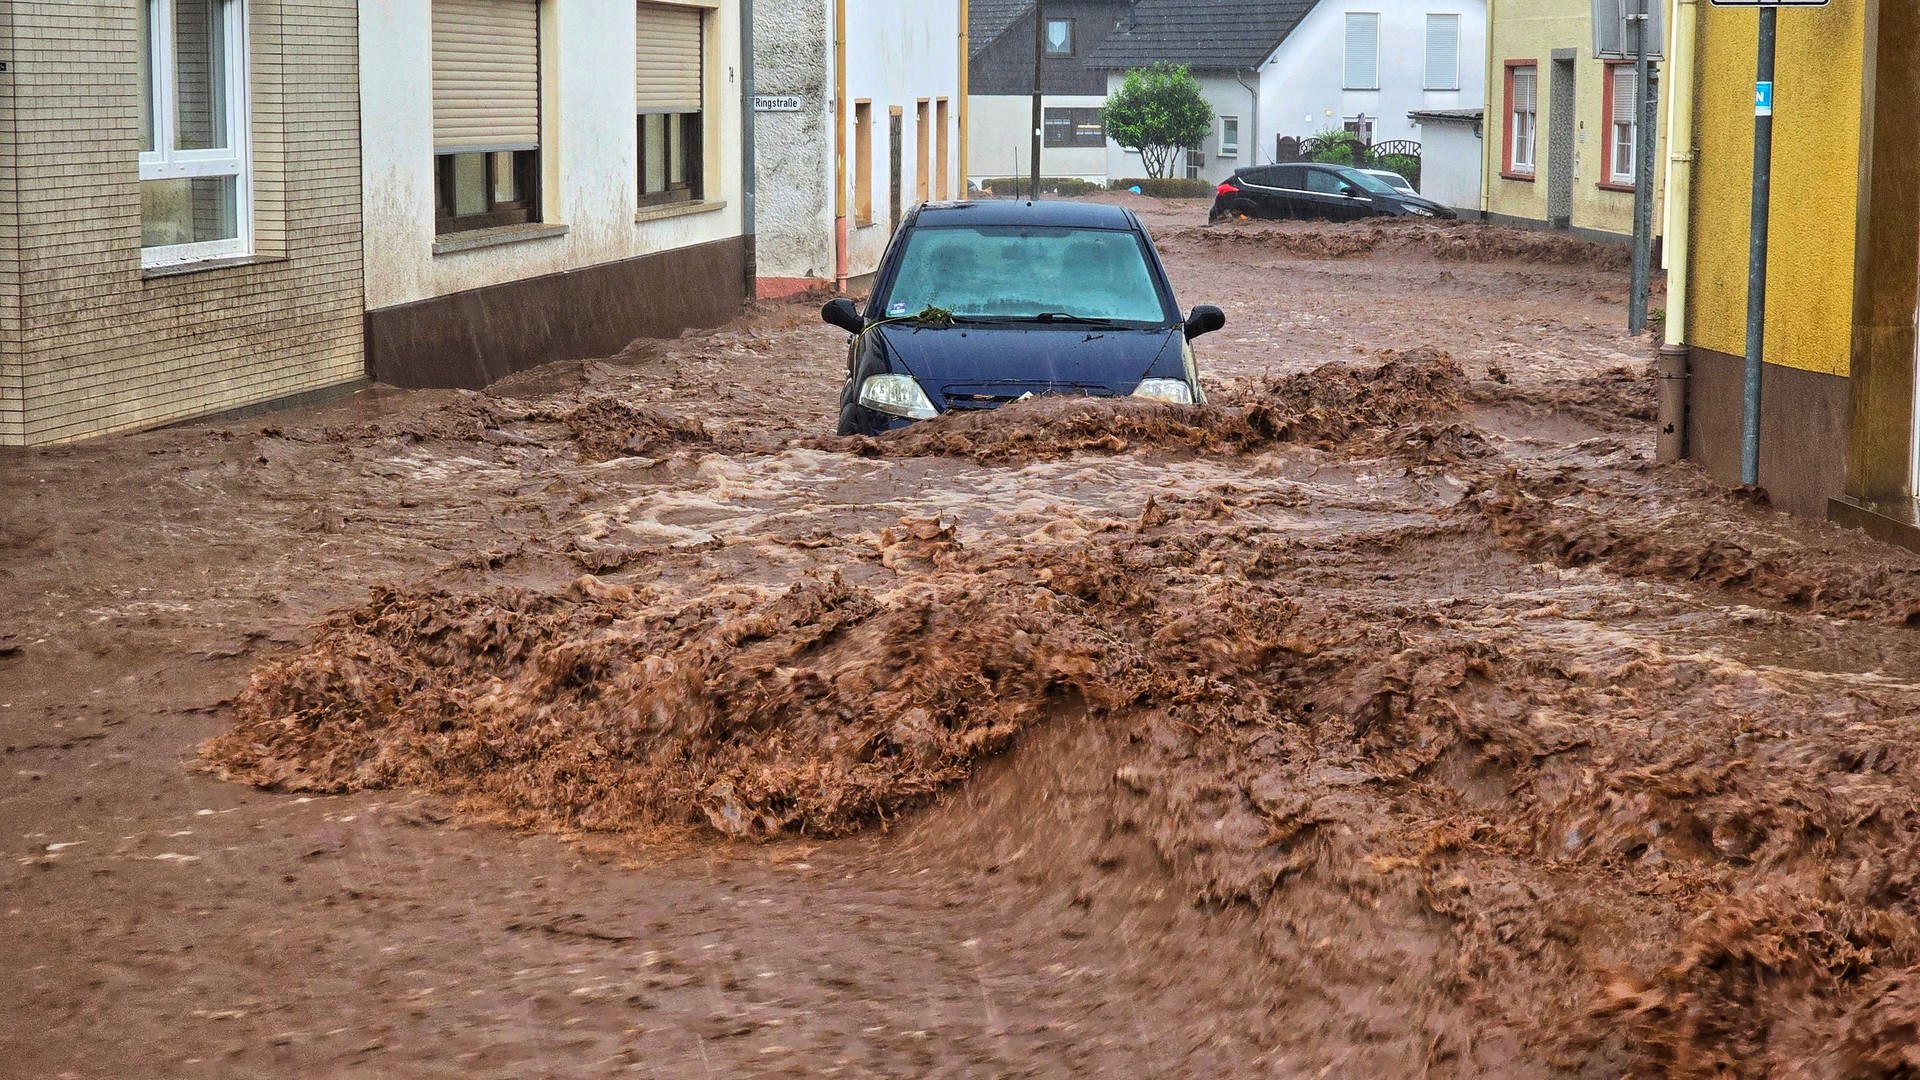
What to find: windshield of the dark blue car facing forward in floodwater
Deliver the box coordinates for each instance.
[885,225,1173,327]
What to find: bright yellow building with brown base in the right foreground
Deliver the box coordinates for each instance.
[1667,0,1920,534]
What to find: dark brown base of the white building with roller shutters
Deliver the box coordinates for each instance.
[367,236,751,390]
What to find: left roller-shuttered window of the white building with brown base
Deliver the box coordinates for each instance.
[434,0,540,233]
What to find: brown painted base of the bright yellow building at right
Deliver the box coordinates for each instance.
[1686,348,1847,517]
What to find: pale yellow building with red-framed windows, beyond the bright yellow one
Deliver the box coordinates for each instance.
[1480,0,1667,240]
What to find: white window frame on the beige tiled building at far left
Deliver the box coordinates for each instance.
[140,0,253,267]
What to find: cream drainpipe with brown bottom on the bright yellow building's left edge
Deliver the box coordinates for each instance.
[1653,0,1699,461]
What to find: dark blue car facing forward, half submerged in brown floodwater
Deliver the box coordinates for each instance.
[820,200,1227,434]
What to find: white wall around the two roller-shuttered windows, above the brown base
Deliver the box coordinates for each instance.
[359,0,741,309]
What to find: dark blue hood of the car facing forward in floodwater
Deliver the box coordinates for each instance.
[868,325,1185,398]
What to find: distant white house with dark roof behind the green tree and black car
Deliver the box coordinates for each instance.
[1089,0,1486,181]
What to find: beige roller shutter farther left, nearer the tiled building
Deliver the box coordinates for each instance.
[432,0,540,154]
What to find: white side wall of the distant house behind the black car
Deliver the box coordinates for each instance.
[1242,0,1486,165]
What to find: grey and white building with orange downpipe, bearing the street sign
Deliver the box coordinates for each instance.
[753,0,966,296]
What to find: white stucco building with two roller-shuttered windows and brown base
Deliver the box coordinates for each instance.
[359,0,751,386]
